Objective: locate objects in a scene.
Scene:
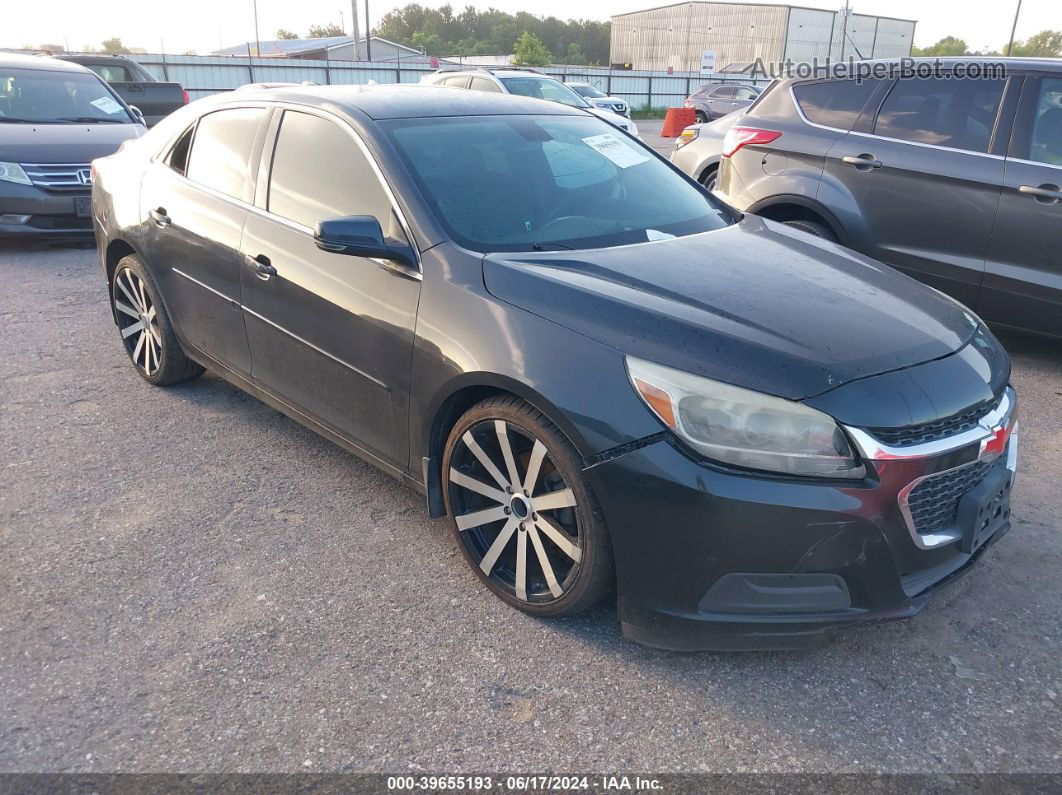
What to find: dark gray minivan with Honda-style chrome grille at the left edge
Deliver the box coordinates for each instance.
[0,53,144,238]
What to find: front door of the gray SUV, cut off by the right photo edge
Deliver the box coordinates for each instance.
[977,73,1062,334]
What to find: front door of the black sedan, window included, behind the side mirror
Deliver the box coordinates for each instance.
[241,105,421,468]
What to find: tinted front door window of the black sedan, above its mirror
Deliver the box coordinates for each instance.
[268,110,401,238]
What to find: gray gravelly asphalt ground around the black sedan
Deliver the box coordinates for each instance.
[0,237,1062,773]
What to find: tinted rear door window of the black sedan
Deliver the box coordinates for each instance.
[187,107,266,204]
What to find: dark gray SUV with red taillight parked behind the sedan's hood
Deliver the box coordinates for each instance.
[717,58,1062,335]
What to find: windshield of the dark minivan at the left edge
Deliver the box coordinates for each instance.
[0,67,133,124]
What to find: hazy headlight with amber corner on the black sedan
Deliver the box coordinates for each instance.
[627,357,866,478]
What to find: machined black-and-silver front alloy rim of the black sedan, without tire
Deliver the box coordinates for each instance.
[448,419,584,605]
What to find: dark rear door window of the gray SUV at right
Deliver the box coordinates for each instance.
[874,77,1006,152]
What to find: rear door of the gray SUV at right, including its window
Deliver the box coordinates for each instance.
[820,76,1007,306]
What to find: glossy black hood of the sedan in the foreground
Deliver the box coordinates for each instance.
[483,215,978,400]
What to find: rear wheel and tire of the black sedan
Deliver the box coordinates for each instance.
[110,254,203,386]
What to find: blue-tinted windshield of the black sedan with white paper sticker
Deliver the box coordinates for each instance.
[383,116,732,252]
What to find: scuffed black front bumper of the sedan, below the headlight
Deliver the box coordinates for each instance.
[586,388,1017,650]
